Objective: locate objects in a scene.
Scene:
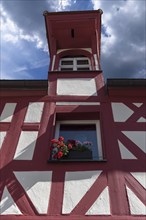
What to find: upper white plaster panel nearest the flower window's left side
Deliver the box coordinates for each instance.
[24,102,44,123]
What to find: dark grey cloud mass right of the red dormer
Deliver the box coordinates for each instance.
[101,0,146,78]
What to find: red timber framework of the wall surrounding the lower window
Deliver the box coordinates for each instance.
[0,83,146,220]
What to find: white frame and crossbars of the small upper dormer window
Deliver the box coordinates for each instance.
[59,57,91,71]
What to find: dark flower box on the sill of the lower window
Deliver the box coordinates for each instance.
[67,150,92,159]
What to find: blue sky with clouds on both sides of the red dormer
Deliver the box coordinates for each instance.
[0,0,146,79]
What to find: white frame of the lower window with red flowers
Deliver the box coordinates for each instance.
[55,120,103,160]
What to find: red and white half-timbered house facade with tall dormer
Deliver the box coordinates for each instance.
[0,10,146,220]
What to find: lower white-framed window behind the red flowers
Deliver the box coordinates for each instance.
[55,120,103,160]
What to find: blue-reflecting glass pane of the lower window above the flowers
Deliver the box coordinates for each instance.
[59,124,98,159]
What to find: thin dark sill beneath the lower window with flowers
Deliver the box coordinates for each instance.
[48,159,107,163]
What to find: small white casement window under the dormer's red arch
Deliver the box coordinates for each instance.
[59,57,91,71]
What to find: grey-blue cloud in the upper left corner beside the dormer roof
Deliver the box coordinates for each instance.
[2,0,58,47]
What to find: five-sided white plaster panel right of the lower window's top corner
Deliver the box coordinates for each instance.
[112,102,134,122]
